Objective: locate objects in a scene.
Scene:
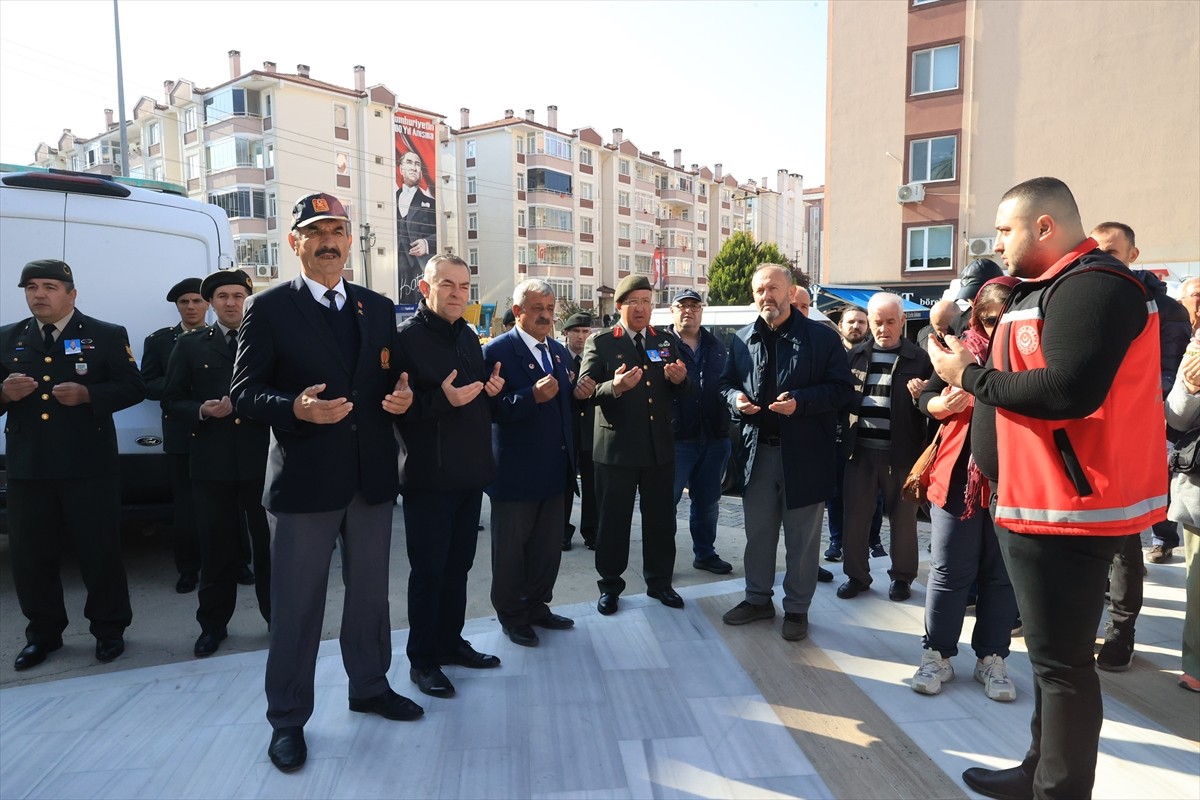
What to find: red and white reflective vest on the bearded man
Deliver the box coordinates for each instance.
[992,239,1166,536]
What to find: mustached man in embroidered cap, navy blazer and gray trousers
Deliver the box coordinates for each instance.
[229,193,424,772]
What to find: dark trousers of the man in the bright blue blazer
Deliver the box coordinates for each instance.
[492,493,568,627]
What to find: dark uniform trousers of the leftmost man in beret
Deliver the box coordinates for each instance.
[8,470,133,646]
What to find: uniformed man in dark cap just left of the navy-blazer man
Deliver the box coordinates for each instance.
[162,269,271,658]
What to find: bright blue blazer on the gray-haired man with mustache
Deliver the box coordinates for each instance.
[484,327,575,501]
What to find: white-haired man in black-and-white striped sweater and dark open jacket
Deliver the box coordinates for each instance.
[838,291,932,602]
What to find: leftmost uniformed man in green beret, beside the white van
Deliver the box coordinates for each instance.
[0,259,145,672]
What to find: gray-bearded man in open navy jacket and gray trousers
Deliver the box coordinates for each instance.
[721,264,853,640]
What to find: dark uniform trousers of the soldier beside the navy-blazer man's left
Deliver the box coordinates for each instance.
[192,480,271,634]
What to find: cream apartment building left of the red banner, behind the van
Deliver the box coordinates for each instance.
[35,50,417,296]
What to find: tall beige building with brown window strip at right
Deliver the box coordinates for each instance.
[821,0,1200,305]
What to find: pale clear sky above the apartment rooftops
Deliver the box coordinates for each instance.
[0,0,827,188]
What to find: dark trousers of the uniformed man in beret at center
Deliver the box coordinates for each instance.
[595,462,676,595]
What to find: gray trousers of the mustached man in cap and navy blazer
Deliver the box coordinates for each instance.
[266,494,392,728]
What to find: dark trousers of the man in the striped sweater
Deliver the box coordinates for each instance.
[841,447,917,585]
